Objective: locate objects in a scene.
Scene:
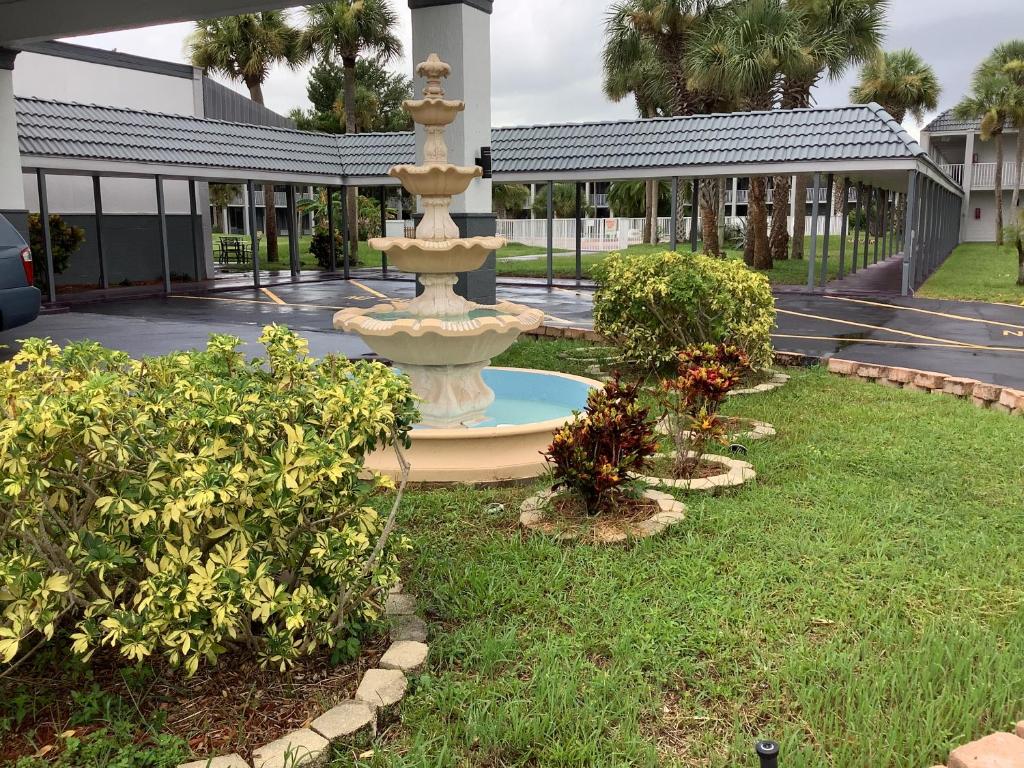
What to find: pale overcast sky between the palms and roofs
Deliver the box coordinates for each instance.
[71,0,1024,135]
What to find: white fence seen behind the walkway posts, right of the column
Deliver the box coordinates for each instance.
[498,216,843,253]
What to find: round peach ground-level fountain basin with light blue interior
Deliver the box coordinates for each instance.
[366,368,602,483]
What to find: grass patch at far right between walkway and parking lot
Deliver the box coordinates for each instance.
[915,243,1024,304]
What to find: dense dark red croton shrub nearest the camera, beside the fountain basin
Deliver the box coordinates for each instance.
[546,374,657,515]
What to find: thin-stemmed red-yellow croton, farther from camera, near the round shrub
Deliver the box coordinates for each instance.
[662,344,750,477]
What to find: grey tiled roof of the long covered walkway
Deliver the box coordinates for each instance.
[16,98,963,293]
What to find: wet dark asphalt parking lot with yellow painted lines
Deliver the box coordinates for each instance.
[8,273,1024,389]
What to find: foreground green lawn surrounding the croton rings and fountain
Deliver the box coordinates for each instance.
[319,342,1024,768]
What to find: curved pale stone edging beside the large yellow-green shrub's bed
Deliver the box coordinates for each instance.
[178,581,430,768]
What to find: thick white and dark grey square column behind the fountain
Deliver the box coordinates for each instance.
[409,0,497,304]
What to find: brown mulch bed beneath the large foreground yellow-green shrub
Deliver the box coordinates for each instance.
[0,634,388,765]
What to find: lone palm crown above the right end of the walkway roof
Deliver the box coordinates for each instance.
[850,48,942,124]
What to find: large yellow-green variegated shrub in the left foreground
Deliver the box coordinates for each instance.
[0,326,416,673]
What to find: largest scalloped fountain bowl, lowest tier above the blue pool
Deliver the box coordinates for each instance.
[334,301,544,367]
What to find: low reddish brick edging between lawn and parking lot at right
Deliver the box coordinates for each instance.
[828,357,1024,415]
